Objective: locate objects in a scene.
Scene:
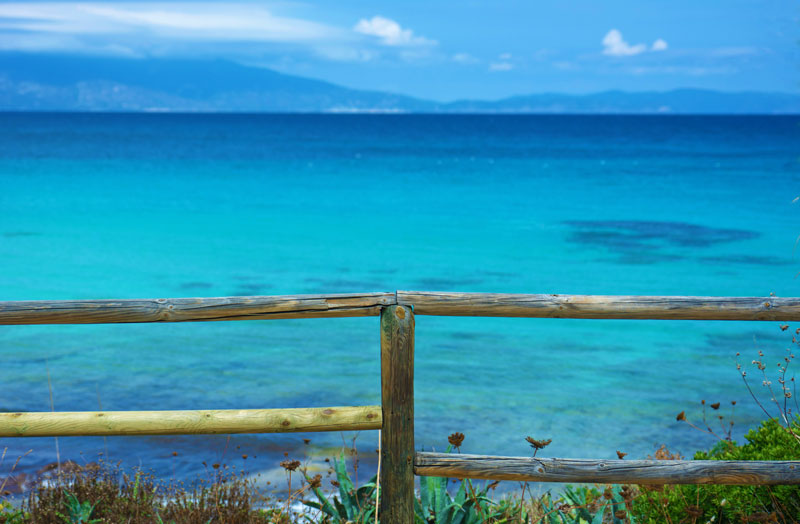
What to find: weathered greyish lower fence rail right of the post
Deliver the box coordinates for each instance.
[414,453,800,485]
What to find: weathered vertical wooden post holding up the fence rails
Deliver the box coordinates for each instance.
[380,306,414,524]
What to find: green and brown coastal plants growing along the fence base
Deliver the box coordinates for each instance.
[0,418,800,524]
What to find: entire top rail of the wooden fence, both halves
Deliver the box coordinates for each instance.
[0,291,800,325]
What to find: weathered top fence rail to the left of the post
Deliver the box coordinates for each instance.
[0,293,395,325]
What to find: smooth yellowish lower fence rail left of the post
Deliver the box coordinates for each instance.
[0,406,381,437]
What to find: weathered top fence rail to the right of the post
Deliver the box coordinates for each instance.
[397,291,800,321]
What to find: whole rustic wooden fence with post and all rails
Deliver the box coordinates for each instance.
[0,291,800,524]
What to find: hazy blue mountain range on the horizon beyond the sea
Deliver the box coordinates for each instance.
[0,53,800,114]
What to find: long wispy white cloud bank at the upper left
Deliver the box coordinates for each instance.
[0,2,346,42]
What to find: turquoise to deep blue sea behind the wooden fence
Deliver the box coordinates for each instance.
[0,114,800,488]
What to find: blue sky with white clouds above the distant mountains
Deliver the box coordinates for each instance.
[0,0,800,101]
